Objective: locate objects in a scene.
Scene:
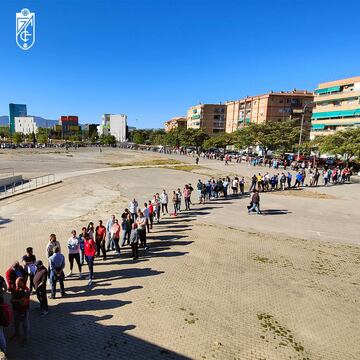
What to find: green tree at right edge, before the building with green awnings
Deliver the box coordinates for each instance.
[315,128,360,161]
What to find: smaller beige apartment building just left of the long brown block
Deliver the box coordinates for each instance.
[187,104,226,135]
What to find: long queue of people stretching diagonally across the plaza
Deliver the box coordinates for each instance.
[0,164,350,360]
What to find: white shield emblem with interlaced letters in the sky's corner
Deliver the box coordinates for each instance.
[16,9,35,50]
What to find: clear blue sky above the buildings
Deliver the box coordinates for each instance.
[0,0,360,128]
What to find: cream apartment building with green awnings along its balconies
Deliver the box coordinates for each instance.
[310,76,360,139]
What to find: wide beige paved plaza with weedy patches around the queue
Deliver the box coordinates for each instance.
[0,149,360,360]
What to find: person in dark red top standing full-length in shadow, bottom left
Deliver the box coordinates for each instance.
[11,278,30,343]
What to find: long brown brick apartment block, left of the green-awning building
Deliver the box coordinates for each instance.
[226,89,314,133]
